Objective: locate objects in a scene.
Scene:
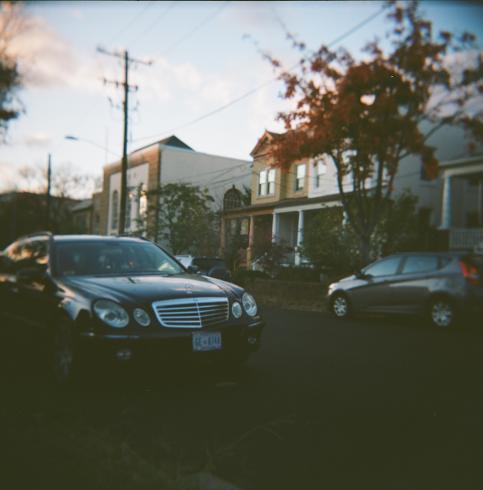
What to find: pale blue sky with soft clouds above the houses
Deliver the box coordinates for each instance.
[0,0,483,196]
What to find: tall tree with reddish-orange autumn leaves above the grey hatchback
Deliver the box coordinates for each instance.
[266,1,483,262]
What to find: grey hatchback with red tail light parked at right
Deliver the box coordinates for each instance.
[328,253,483,327]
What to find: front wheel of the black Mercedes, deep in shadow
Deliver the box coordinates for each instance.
[51,321,75,385]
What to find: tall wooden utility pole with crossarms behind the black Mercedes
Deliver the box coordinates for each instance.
[97,47,152,235]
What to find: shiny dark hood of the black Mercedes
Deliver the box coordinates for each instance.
[63,274,231,304]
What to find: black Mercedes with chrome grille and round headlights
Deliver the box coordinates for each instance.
[0,233,264,383]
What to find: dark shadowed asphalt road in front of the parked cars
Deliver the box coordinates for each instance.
[0,309,483,490]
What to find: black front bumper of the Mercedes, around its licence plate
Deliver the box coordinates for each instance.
[78,319,265,361]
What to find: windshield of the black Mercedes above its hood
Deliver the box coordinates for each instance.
[55,240,185,276]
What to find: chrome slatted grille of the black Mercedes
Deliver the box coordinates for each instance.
[153,298,229,328]
